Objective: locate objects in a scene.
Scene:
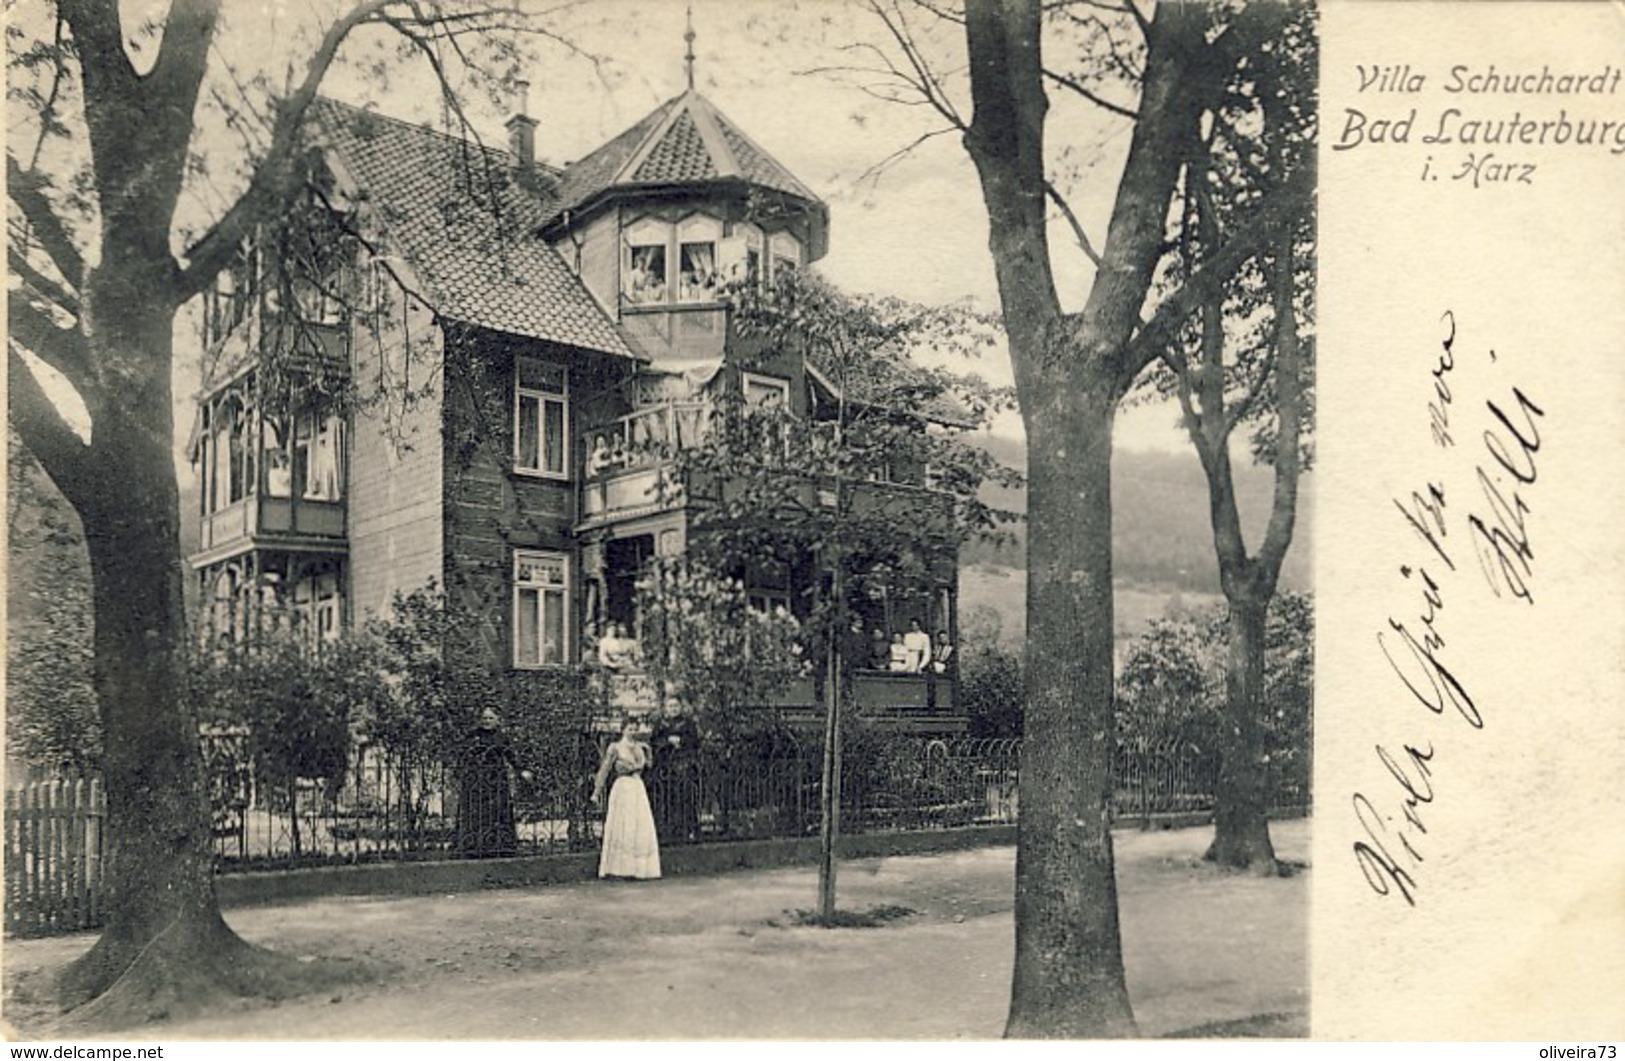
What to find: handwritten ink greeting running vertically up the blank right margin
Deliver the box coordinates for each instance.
[1352,310,1545,907]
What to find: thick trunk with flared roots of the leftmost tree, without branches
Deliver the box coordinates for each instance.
[59,281,352,1029]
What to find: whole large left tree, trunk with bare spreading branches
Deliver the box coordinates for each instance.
[7,0,591,1024]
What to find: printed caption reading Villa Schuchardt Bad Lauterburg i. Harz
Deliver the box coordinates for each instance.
[1326,63,1625,188]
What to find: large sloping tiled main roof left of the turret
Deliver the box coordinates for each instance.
[312,99,635,357]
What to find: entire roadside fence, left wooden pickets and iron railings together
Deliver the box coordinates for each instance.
[5,731,1308,934]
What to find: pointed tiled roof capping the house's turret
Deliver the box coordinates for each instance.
[551,89,817,218]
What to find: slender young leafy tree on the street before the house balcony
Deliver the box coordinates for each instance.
[676,273,1017,923]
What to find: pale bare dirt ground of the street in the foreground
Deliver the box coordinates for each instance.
[5,821,1308,1040]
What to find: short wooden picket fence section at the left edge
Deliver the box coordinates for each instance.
[5,780,107,936]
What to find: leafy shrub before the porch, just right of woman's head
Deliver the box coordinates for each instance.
[637,557,809,744]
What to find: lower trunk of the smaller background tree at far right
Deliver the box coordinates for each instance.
[1206,591,1279,876]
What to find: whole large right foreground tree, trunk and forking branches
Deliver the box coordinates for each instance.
[871,0,1313,1038]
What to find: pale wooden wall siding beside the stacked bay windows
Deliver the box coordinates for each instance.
[348,300,445,626]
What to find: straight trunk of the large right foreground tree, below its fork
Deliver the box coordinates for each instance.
[1004,392,1136,1038]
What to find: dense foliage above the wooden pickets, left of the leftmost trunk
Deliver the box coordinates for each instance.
[5,437,101,777]
